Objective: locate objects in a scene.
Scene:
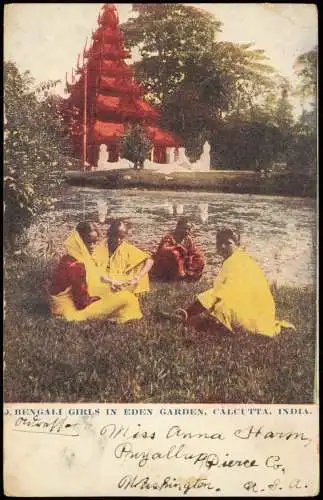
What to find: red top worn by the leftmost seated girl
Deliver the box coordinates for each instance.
[49,255,101,309]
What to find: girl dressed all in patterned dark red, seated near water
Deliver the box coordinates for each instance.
[152,217,204,281]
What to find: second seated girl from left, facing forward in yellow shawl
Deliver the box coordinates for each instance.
[94,219,154,294]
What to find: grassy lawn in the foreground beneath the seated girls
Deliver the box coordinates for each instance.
[4,257,315,404]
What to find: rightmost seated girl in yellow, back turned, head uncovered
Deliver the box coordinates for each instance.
[177,228,295,337]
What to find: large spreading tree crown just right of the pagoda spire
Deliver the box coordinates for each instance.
[121,3,274,113]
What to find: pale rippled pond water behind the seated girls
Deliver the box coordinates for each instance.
[29,186,317,287]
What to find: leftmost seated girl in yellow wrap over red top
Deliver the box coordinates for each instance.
[49,222,142,323]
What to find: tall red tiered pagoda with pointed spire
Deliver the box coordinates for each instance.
[66,4,181,167]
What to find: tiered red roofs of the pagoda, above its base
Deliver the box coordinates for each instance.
[66,4,181,153]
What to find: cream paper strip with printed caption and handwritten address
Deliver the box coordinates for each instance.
[4,405,319,497]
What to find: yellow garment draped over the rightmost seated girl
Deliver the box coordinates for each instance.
[197,248,295,337]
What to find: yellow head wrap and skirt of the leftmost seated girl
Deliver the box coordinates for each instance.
[50,231,142,323]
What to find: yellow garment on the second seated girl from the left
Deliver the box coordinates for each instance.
[93,240,150,294]
